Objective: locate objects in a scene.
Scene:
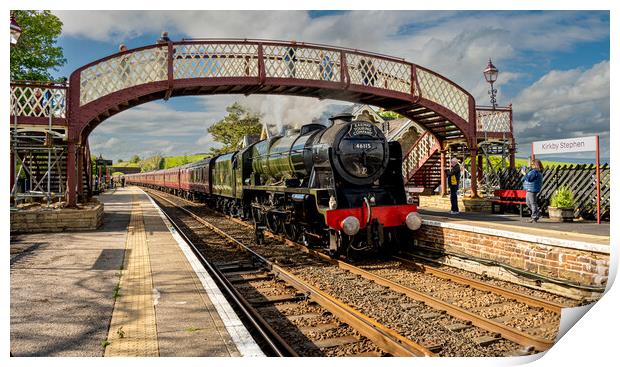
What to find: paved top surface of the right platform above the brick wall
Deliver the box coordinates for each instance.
[419,208,609,244]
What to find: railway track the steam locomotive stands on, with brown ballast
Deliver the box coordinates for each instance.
[144,187,562,356]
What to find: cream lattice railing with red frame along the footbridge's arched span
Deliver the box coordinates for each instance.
[69,39,473,121]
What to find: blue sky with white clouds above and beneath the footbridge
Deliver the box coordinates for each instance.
[49,11,610,160]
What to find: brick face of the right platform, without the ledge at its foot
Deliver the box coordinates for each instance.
[416,223,609,294]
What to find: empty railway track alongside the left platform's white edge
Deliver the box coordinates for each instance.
[149,191,434,356]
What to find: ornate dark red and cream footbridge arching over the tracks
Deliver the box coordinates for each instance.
[12,39,476,205]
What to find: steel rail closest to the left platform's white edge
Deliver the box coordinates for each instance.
[151,193,299,357]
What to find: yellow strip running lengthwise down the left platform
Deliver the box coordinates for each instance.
[105,195,159,357]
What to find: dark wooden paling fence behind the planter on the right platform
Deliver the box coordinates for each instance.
[498,164,611,220]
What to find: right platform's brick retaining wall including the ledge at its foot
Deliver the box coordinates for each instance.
[414,220,609,298]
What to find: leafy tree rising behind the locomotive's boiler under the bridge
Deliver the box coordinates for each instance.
[207,102,262,154]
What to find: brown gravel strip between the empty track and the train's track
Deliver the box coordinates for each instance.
[148,194,532,356]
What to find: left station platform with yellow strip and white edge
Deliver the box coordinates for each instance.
[10,188,263,357]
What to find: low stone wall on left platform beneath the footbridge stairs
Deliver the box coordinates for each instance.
[11,202,103,233]
